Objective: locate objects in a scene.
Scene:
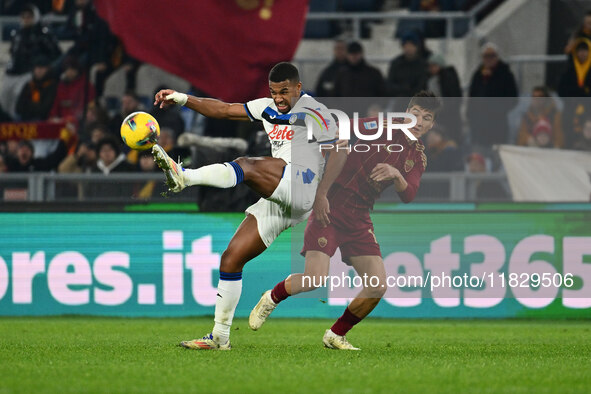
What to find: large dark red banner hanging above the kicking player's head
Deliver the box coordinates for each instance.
[95,0,308,102]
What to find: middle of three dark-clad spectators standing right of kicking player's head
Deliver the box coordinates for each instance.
[388,33,428,97]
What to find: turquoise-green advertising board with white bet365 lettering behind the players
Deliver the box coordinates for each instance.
[0,210,591,318]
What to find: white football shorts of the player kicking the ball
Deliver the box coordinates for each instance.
[246,164,318,247]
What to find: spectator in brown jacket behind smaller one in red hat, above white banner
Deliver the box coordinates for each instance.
[517,86,564,148]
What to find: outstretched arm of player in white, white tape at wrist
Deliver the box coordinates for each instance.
[154,89,250,120]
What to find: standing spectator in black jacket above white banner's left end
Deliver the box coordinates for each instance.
[467,43,517,147]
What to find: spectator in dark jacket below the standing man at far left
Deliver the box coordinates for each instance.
[16,56,57,121]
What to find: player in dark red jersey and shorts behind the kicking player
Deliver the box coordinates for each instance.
[249,91,440,350]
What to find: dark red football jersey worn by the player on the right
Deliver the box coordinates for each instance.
[329,118,427,209]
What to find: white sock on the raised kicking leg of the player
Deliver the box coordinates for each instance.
[183,162,244,189]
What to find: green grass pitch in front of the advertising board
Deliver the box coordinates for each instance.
[0,317,591,393]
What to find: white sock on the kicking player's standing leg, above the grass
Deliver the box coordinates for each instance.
[212,272,242,344]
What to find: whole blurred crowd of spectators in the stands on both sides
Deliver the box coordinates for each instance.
[0,0,591,203]
